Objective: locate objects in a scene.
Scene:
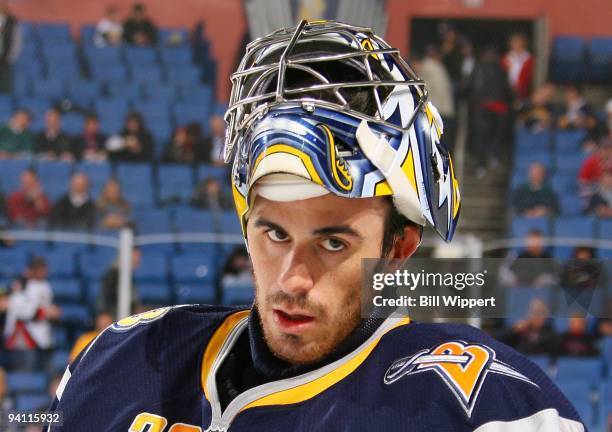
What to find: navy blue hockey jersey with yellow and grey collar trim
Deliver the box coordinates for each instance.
[47,305,585,432]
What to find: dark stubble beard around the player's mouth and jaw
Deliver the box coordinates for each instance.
[254,277,361,365]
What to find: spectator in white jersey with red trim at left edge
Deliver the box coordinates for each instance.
[4,257,61,370]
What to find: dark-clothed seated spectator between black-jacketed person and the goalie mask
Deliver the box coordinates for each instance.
[163,123,210,164]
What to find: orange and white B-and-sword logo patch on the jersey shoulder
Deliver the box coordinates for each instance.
[384,341,538,417]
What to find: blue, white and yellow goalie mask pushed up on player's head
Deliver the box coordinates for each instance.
[225,21,460,241]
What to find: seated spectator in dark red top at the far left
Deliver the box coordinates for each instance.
[7,170,51,228]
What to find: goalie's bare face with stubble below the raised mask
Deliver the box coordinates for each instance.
[247,194,388,364]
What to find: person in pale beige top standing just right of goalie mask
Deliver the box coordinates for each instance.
[415,46,455,148]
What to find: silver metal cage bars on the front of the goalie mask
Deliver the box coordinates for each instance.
[224,20,427,163]
